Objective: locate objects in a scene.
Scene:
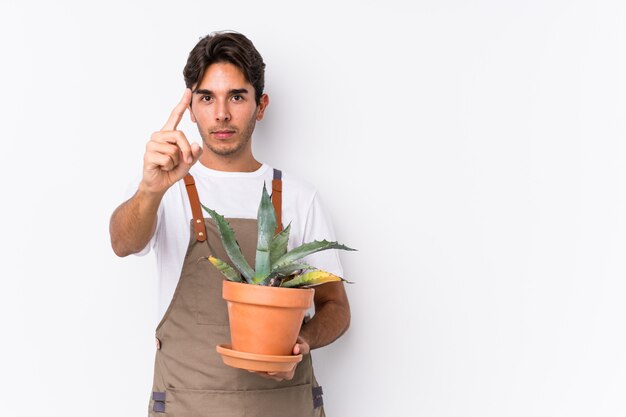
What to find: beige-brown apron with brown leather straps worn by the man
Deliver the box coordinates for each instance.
[148,170,324,417]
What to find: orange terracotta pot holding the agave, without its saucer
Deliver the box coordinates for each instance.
[222,280,315,355]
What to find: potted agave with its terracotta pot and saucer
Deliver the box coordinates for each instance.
[202,185,354,370]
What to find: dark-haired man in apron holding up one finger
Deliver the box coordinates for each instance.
[110,33,350,417]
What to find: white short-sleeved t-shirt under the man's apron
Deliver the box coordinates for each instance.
[127,162,343,319]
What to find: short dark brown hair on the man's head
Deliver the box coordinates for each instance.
[183,32,265,104]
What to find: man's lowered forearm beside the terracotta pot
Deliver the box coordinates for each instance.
[300,283,350,349]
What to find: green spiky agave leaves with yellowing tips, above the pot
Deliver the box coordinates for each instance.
[202,184,355,288]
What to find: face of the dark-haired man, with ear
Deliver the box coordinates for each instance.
[191,62,268,156]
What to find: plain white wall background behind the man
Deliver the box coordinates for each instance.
[0,0,626,417]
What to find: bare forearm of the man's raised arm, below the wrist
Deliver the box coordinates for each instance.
[109,187,163,256]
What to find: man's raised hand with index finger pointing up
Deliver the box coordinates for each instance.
[139,88,202,194]
